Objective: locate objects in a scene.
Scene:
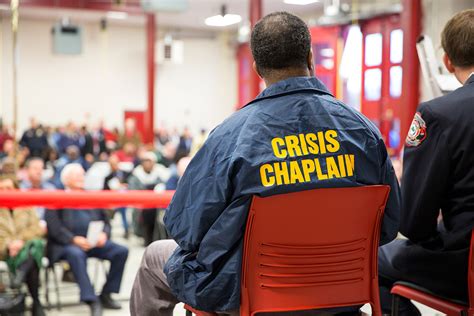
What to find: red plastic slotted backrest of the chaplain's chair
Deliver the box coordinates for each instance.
[241,185,390,315]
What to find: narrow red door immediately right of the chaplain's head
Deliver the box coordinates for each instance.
[311,26,341,97]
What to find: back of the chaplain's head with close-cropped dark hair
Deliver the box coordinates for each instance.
[250,12,311,76]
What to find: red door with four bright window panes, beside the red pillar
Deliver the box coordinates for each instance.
[361,15,403,155]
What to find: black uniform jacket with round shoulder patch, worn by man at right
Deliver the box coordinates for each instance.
[400,75,474,251]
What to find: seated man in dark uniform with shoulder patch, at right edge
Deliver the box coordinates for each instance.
[379,9,474,315]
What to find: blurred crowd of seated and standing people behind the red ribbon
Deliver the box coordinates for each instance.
[0,119,202,315]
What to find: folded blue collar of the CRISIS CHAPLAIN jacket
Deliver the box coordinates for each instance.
[252,77,331,102]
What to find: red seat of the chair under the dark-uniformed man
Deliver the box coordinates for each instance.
[391,281,469,315]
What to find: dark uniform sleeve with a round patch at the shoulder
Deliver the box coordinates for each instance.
[400,103,449,242]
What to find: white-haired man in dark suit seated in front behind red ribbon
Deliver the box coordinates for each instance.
[45,163,128,316]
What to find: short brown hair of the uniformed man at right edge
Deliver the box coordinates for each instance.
[441,9,474,68]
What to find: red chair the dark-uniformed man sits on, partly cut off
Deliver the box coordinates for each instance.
[391,230,474,316]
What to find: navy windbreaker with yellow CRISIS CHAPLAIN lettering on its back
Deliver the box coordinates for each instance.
[164,77,400,311]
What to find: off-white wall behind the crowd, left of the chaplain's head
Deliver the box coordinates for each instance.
[0,16,237,134]
